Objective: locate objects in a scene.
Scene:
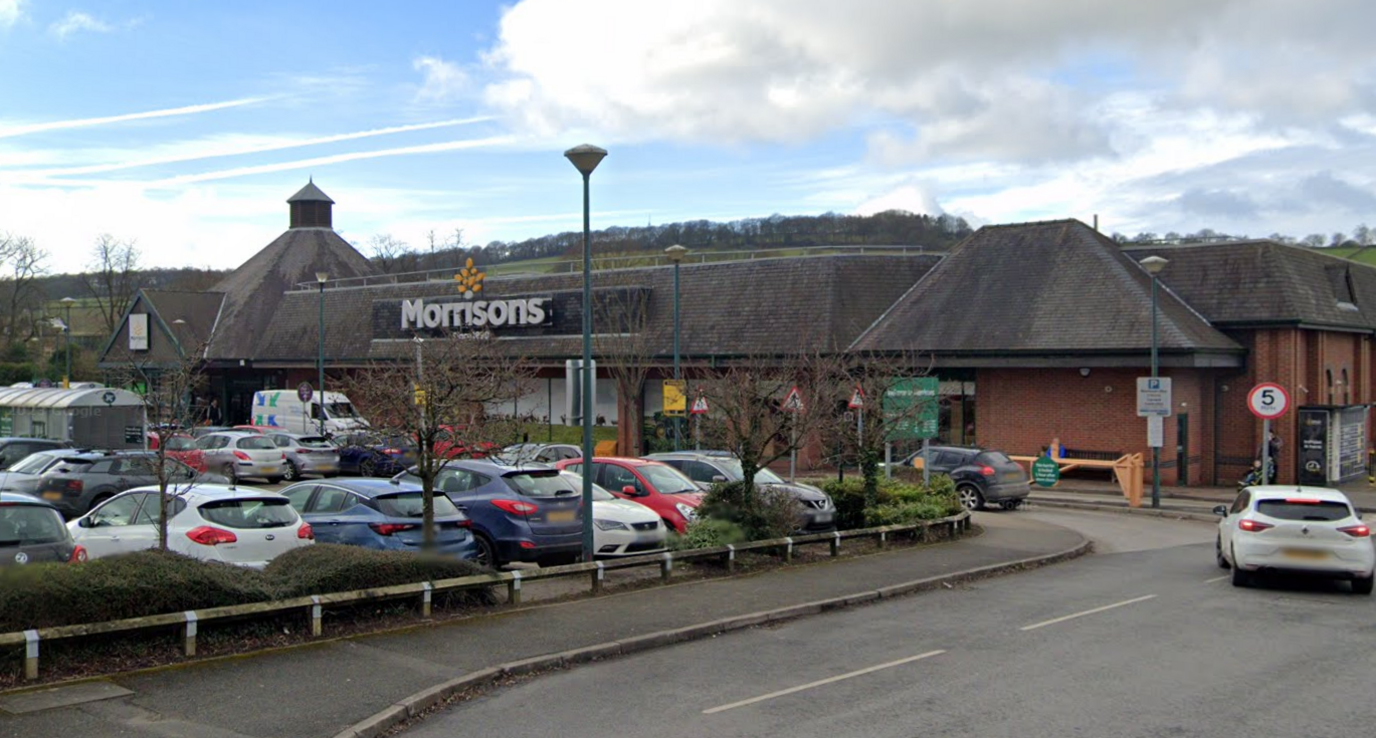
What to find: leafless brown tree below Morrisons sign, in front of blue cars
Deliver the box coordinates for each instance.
[343,333,534,551]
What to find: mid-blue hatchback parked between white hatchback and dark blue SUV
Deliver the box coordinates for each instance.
[282,479,477,560]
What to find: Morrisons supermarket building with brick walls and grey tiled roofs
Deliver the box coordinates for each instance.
[102,183,1376,485]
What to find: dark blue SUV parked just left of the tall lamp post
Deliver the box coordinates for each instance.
[394,458,583,569]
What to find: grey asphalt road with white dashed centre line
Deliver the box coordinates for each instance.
[406,511,1376,738]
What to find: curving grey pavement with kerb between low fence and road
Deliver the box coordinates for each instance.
[0,512,1088,738]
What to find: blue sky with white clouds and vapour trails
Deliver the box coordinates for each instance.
[0,0,1376,271]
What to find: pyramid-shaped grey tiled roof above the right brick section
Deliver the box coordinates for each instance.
[854,220,1241,355]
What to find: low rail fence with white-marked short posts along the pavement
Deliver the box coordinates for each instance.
[0,512,970,680]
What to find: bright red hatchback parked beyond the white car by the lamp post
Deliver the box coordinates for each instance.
[555,456,705,533]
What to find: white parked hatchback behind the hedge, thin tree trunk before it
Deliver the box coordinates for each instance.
[67,485,315,569]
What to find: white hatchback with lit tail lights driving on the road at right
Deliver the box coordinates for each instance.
[1214,485,1376,595]
